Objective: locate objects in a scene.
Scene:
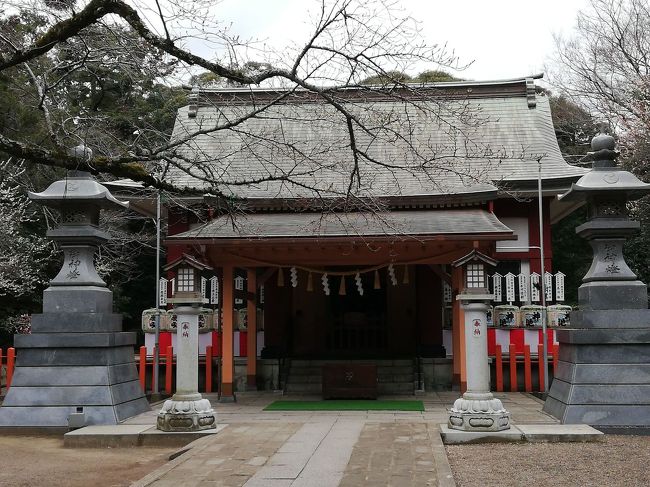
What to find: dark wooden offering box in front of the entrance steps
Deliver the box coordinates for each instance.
[323,364,377,399]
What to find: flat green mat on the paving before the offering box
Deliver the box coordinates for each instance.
[264,399,424,411]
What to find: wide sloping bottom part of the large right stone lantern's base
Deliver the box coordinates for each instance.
[544,322,650,428]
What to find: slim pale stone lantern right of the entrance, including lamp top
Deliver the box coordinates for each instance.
[448,250,510,432]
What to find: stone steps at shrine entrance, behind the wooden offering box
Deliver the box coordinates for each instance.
[284,359,417,395]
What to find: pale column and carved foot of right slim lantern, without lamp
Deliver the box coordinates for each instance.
[448,295,510,431]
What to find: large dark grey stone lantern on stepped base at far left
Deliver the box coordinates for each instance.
[0,151,149,427]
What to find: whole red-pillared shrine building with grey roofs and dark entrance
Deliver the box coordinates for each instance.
[147,74,585,397]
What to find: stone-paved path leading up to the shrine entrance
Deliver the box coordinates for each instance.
[129,392,557,487]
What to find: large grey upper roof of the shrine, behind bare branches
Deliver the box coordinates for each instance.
[166,79,585,206]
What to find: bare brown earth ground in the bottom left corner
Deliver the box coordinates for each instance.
[0,436,178,487]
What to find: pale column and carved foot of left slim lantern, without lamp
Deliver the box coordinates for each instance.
[157,303,216,431]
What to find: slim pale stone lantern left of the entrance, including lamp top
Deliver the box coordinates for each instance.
[157,254,216,431]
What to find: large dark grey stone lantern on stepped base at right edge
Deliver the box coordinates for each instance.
[544,132,650,428]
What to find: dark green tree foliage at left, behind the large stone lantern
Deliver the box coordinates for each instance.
[0,11,187,338]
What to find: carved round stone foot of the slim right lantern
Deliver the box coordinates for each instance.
[448,392,510,431]
